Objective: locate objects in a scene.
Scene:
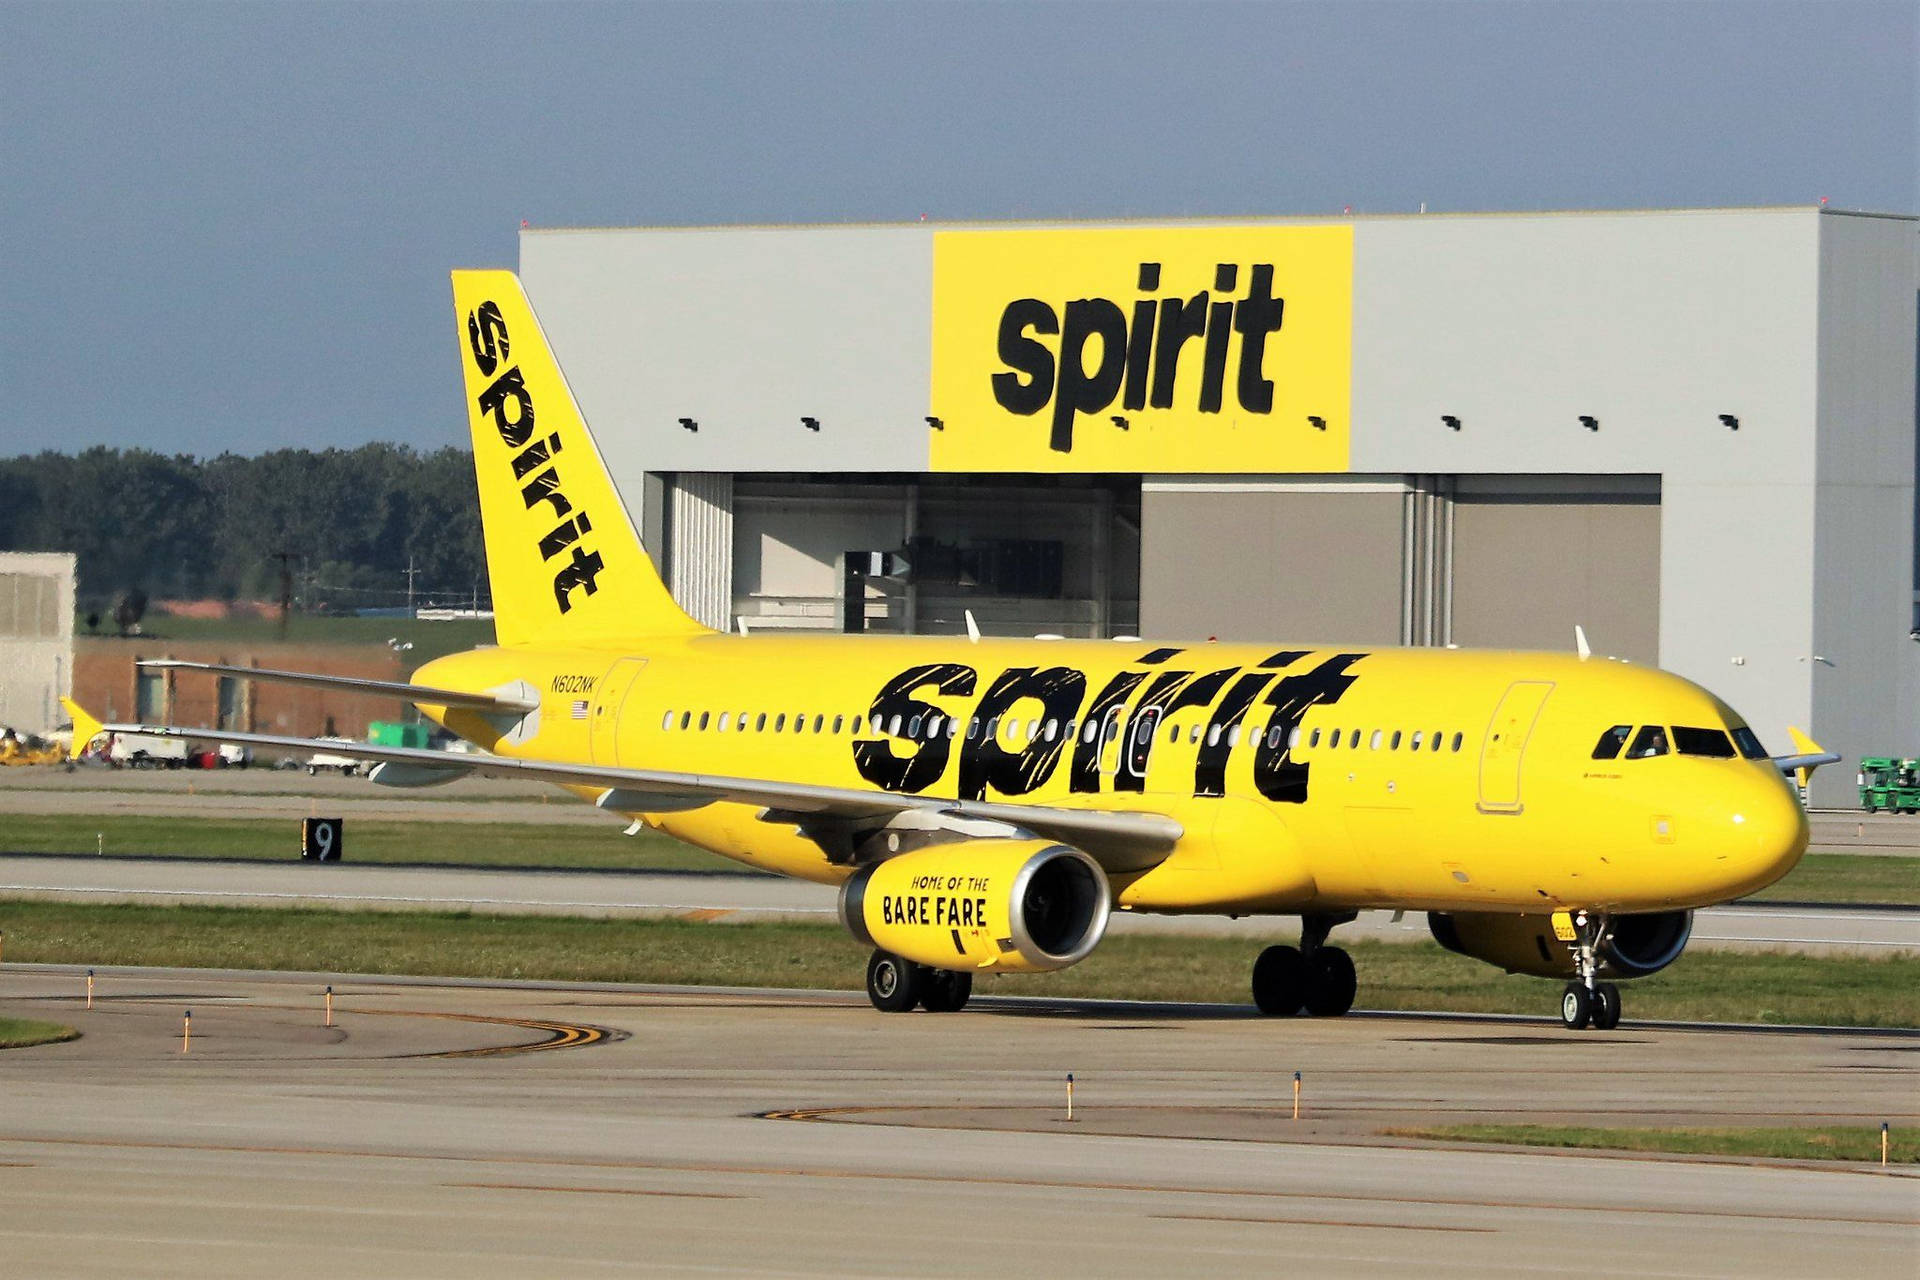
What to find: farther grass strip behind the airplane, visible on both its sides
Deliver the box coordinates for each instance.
[0,817,1920,906]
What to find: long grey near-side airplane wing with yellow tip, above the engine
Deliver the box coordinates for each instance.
[63,700,1185,871]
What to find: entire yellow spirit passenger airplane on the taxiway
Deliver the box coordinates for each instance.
[69,271,1837,1029]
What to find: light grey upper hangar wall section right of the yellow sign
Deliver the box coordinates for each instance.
[1352,209,1820,480]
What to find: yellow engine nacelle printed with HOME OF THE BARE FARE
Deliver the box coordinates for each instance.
[839,839,1112,973]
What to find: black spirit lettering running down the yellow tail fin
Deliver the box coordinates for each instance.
[467,301,605,614]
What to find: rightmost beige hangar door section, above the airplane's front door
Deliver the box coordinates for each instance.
[1450,476,1661,666]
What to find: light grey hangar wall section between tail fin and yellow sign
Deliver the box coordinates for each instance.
[520,226,933,475]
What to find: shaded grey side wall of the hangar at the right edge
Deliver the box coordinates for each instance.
[1812,215,1920,802]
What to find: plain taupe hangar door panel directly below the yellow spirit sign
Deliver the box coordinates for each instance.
[1140,478,1405,645]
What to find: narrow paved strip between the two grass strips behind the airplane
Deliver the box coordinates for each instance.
[0,856,1920,956]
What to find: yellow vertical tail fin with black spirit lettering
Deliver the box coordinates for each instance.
[453,271,707,645]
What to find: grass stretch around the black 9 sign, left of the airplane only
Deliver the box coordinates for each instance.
[0,817,743,871]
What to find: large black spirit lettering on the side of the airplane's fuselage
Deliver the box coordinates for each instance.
[852,649,1367,804]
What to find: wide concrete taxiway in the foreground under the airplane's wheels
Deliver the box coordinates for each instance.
[0,965,1920,1278]
